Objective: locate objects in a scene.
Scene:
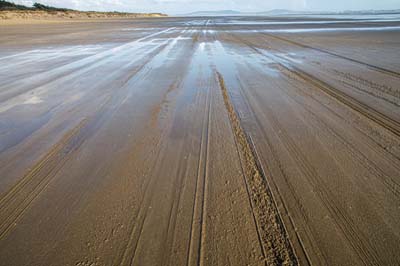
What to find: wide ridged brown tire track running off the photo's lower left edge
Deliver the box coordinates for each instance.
[0,34,180,242]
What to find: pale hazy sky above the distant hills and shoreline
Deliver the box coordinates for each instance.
[14,0,400,14]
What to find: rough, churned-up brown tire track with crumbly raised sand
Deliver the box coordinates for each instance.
[217,72,298,265]
